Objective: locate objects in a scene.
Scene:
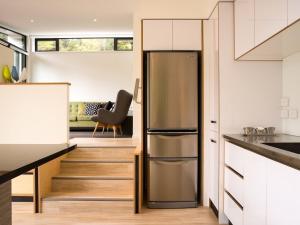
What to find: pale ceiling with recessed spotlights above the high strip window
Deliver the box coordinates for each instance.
[0,0,217,35]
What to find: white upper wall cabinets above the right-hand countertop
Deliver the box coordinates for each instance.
[234,0,300,60]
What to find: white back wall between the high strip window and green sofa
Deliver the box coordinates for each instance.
[30,52,134,101]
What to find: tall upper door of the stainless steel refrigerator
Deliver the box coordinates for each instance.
[147,52,198,131]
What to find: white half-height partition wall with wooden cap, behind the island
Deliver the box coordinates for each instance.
[0,84,69,144]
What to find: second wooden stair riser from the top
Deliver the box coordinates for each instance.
[59,161,134,177]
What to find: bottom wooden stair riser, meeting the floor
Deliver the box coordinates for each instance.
[42,201,133,216]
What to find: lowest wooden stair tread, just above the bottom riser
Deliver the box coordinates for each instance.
[43,191,133,201]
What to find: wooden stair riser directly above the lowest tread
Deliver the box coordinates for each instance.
[52,177,134,195]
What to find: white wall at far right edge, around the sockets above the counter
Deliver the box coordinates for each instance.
[282,52,300,136]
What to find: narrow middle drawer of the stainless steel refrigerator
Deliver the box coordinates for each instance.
[147,132,198,157]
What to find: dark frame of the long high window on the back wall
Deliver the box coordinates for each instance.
[34,37,133,53]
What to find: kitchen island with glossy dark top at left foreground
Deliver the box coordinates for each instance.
[0,144,76,225]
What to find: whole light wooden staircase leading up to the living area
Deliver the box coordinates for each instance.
[42,146,135,213]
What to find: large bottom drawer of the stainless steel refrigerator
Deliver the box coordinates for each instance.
[148,158,197,207]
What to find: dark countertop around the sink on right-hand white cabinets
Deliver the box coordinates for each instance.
[223,134,300,170]
